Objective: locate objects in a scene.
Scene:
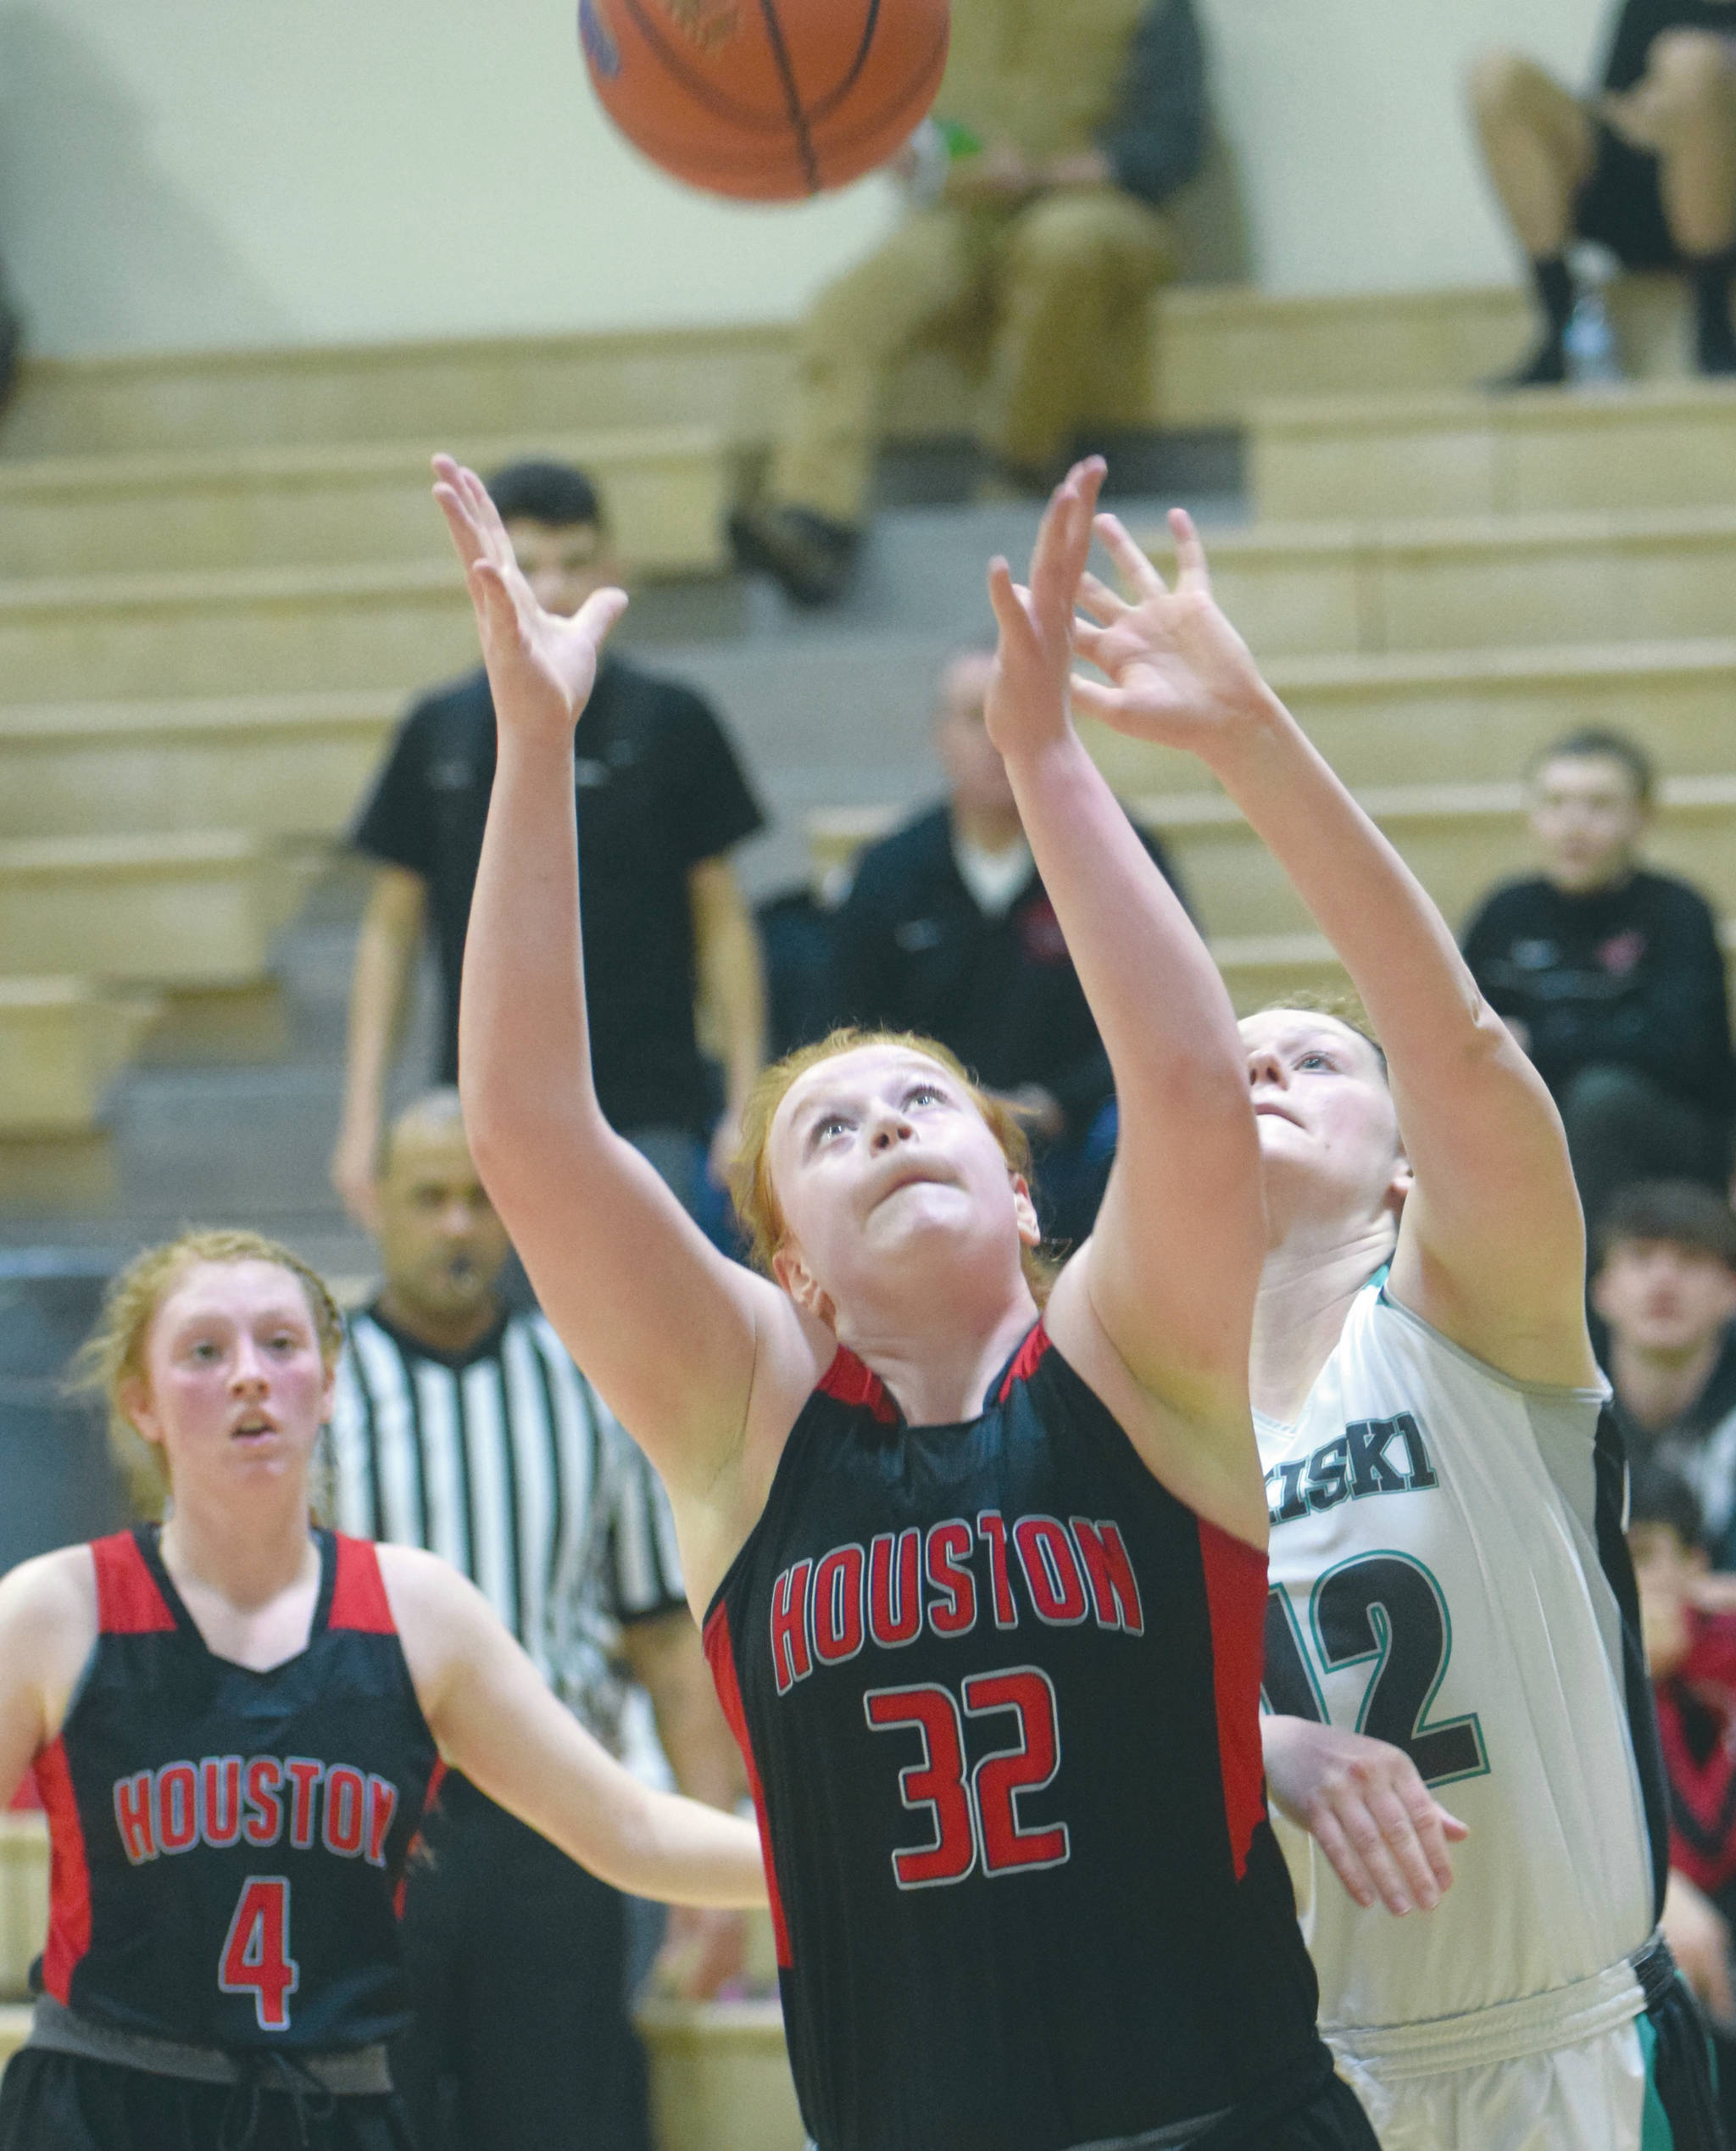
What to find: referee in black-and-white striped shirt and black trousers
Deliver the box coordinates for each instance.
[331,1090,737,2151]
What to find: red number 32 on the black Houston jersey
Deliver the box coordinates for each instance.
[863,1665,1067,1888]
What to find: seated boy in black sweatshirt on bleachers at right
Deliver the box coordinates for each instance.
[1465,722,1736,1230]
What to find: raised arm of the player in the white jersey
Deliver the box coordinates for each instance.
[1073,510,1596,1383]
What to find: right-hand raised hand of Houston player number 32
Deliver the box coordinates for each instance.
[983,456,1105,755]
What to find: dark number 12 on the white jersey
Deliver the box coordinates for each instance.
[1260,1553,1488,1786]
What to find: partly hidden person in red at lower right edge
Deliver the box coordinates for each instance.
[1628,1465,1736,2130]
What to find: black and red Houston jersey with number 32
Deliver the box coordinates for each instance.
[705,1325,1316,2151]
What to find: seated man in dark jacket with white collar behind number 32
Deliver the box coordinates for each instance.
[831,652,1175,1243]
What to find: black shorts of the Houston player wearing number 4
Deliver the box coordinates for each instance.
[0,2046,415,2151]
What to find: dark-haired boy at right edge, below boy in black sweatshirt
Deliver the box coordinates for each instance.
[1592,1181,1736,1570]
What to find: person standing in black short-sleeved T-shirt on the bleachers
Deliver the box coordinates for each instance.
[331,462,764,1226]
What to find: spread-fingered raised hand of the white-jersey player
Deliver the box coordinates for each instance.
[1073,508,1269,753]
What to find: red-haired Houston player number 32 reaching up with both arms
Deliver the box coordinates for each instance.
[437,445,1372,2151]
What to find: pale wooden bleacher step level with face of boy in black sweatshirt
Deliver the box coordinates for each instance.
[809,772,1736,940]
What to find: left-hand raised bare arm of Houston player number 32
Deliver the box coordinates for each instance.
[435,456,824,1548]
